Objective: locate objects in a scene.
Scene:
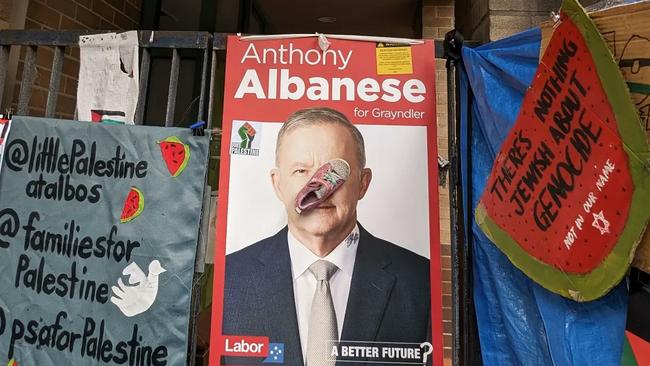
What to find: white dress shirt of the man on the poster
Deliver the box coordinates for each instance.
[287,225,359,358]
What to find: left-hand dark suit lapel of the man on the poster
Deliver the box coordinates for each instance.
[253,227,303,366]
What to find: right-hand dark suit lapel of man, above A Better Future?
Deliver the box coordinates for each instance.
[341,225,395,341]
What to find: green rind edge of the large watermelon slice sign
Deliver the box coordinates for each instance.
[475,0,650,301]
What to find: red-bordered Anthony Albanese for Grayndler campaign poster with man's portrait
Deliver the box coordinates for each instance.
[210,36,442,366]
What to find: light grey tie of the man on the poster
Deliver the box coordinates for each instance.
[306,259,339,366]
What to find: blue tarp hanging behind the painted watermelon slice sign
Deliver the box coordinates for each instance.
[460,29,628,366]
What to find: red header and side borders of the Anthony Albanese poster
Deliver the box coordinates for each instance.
[210,36,443,365]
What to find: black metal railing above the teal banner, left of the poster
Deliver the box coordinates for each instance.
[0,30,225,127]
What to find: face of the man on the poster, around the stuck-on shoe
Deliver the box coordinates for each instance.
[271,123,372,240]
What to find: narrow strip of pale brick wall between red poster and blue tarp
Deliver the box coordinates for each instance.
[422,0,454,365]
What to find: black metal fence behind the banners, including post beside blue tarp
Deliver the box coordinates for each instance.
[0,30,480,365]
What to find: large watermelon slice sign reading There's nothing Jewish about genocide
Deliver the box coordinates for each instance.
[475,0,650,301]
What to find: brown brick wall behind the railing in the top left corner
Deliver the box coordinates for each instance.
[13,0,143,118]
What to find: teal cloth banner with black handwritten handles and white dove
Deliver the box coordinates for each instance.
[0,116,208,366]
